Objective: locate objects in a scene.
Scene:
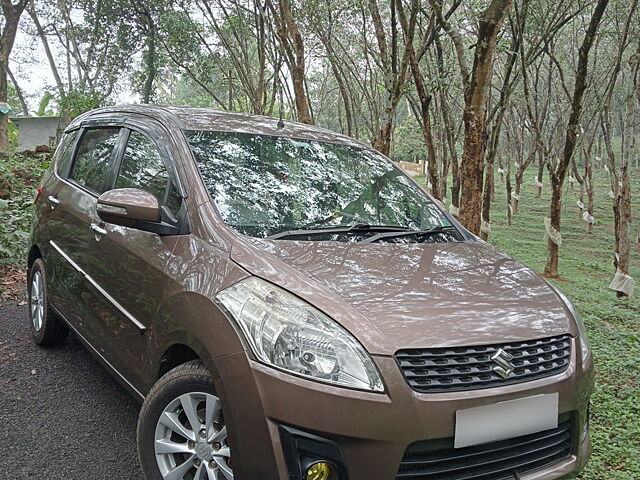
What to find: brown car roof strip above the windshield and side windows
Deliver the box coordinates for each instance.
[73,105,371,149]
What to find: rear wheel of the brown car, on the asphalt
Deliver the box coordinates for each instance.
[27,258,69,347]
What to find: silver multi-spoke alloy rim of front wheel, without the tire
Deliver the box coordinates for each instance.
[154,392,233,480]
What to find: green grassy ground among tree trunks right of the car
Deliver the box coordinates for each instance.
[476,169,640,480]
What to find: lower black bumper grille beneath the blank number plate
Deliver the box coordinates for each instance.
[396,419,573,480]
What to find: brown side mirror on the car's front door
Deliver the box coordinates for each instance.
[96,188,169,235]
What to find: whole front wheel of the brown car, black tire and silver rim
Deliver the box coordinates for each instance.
[137,360,233,480]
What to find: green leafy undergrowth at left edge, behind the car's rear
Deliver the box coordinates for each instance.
[0,154,50,263]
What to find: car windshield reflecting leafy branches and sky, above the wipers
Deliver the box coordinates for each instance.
[186,131,451,241]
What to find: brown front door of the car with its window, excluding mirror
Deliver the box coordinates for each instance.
[88,121,186,390]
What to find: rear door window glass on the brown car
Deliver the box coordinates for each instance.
[71,127,120,194]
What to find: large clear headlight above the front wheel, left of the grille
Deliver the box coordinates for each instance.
[216,277,384,392]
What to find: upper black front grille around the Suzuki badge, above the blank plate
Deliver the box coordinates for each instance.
[395,335,571,393]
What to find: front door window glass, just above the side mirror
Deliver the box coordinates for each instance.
[116,131,182,215]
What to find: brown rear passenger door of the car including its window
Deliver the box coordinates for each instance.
[43,122,121,336]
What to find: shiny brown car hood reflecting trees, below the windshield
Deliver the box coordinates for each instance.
[231,237,575,355]
